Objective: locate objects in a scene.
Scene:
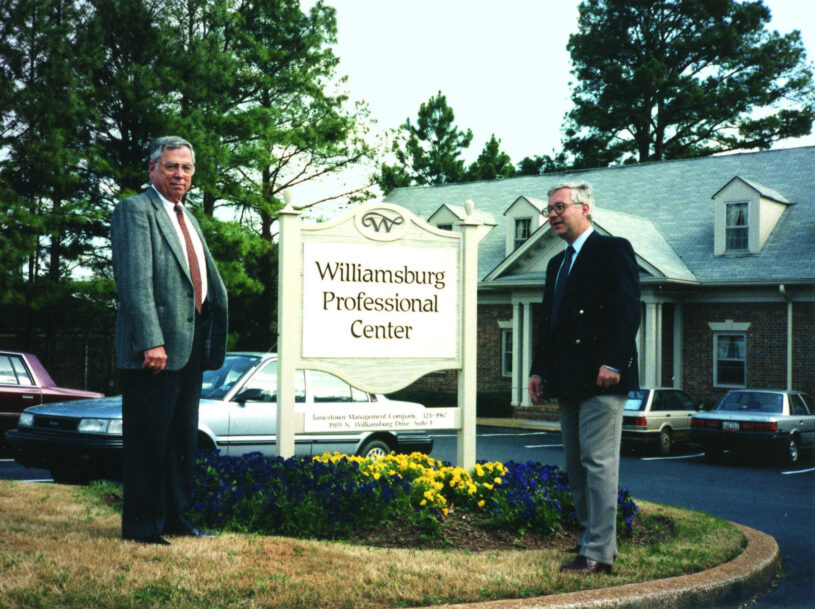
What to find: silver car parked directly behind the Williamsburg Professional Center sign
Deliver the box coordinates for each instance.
[6,353,433,482]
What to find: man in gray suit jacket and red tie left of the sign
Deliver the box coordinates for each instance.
[111,137,227,545]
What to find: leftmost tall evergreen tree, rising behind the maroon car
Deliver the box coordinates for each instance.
[0,0,102,361]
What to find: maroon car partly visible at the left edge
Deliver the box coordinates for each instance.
[0,351,104,447]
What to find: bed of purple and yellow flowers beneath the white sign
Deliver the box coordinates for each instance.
[192,453,637,539]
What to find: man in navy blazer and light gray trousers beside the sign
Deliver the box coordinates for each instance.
[529,182,640,574]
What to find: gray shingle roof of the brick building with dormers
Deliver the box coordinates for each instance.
[386,146,815,283]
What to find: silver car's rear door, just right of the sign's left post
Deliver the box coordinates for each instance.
[306,370,371,455]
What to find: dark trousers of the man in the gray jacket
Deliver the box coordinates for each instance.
[120,315,203,539]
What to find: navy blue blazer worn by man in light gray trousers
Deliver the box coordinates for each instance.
[530,231,641,400]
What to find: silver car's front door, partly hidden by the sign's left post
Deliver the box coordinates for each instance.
[225,360,311,457]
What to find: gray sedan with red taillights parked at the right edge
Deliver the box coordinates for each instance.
[691,389,815,464]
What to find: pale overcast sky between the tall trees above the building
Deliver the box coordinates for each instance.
[298,0,815,202]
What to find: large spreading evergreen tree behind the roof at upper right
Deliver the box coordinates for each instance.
[565,0,815,166]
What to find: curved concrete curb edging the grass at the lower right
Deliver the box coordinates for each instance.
[418,523,781,609]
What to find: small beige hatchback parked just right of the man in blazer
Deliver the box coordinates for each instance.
[622,387,702,455]
